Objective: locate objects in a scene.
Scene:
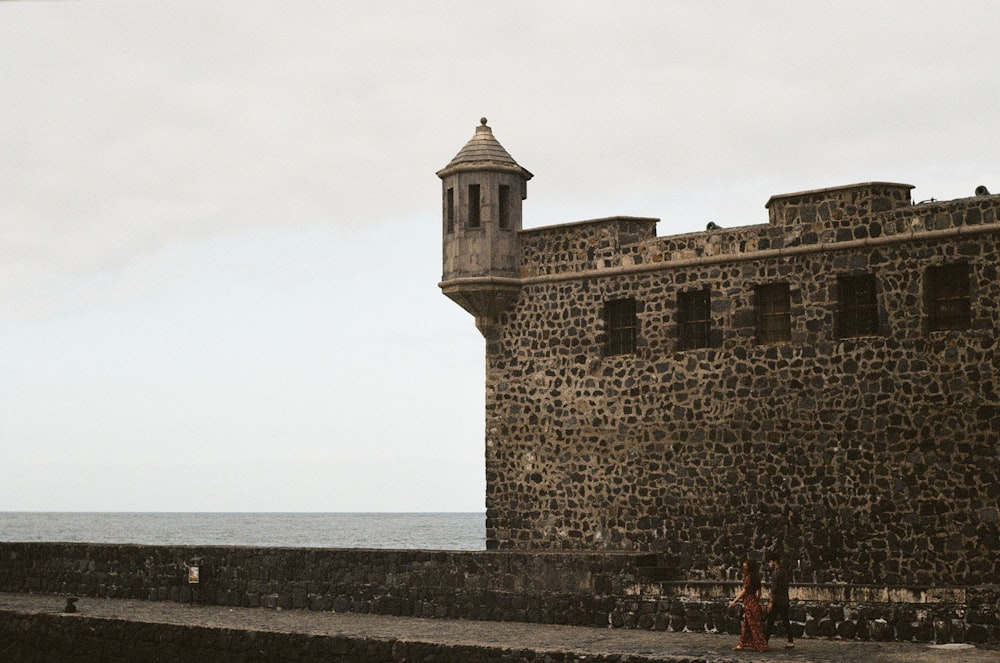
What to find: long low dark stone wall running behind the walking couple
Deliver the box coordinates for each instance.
[0,543,1000,644]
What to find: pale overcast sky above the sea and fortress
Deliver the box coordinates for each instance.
[0,0,1000,511]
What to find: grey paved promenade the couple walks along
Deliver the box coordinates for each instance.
[0,593,1000,663]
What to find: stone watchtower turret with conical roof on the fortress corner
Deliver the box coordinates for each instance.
[437,117,532,336]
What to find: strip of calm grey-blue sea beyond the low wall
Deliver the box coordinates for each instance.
[0,512,486,550]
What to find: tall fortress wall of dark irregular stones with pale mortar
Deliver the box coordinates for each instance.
[486,183,1000,585]
